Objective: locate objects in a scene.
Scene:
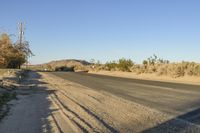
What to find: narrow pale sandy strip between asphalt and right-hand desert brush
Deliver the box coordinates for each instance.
[89,71,200,85]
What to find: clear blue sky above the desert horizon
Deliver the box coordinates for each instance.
[0,0,200,64]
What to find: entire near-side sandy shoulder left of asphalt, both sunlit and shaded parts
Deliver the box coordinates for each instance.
[0,72,200,133]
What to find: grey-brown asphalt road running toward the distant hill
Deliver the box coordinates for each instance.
[51,72,200,117]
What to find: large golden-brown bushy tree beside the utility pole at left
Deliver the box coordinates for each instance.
[0,33,33,68]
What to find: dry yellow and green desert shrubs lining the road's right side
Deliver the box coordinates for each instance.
[90,55,200,78]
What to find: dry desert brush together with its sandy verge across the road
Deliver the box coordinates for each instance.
[90,55,200,84]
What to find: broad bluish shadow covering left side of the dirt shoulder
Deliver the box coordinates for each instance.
[0,72,62,133]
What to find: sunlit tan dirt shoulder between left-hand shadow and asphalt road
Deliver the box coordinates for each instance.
[41,73,199,132]
